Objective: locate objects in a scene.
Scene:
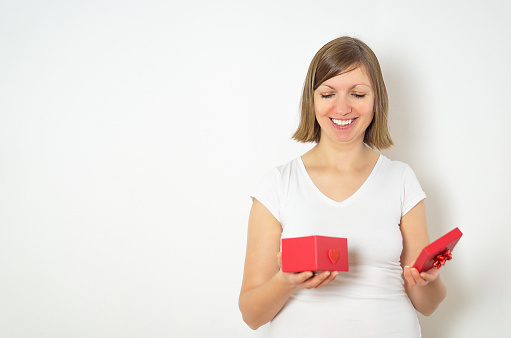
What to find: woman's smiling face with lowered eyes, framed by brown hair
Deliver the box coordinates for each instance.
[314,67,374,144]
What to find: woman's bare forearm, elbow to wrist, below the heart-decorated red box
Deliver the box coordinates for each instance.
[239,272,296,330]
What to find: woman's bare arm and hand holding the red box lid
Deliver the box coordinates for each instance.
[401,201,446,316]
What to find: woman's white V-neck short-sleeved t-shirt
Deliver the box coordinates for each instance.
[252,155,426,338]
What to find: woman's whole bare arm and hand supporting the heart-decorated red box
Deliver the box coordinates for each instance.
[239,200,337,330]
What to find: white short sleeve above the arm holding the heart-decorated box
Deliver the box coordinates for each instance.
[250,168,281,222]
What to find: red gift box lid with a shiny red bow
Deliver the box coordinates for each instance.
[413,228,463,272]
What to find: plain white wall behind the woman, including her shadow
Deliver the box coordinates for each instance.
[0,0,511,338]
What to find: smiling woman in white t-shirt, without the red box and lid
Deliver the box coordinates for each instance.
[239,37,446,338]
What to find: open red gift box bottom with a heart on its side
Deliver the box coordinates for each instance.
[282,236,349,272]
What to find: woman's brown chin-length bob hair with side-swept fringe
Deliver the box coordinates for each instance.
[293,36,394,150]
